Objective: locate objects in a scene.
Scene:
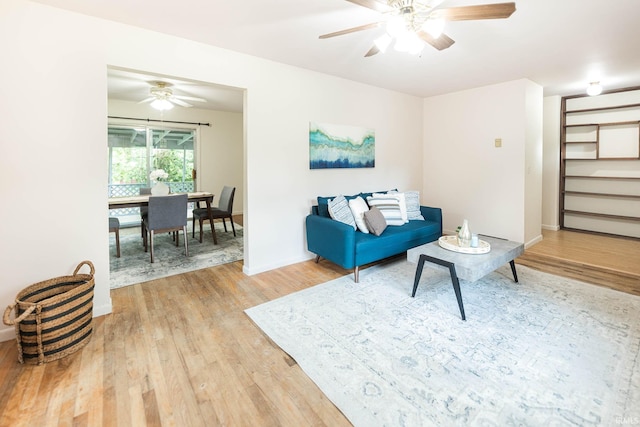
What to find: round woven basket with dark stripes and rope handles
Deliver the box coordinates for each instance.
[3,261,95,365]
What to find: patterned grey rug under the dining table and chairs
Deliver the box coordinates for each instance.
[109,222,244,289]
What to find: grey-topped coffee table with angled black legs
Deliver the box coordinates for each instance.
[407,235,524,320]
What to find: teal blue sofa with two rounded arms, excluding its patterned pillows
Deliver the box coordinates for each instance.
[305,193,442,283]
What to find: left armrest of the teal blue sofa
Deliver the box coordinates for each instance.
[305,215,356,268]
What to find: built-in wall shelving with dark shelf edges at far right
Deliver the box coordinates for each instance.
[560,87,640,238]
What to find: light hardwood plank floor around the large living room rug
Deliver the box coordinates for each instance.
[0,229,640,426]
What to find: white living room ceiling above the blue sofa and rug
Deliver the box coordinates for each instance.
[37,0,640,112]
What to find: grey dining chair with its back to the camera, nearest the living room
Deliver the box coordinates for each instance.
[142,194,189,262]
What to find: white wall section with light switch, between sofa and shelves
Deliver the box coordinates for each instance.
[422,80,542,243]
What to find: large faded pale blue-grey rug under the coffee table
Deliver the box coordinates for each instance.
[246,260,640,427]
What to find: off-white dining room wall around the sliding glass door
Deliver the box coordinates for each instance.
[108,100,244,214]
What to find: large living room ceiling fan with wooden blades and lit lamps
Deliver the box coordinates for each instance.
[320,0,516,57]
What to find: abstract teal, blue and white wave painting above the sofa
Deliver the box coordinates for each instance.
[309,122,376,169]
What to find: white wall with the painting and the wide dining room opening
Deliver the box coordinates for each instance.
[0,0,423,340]
